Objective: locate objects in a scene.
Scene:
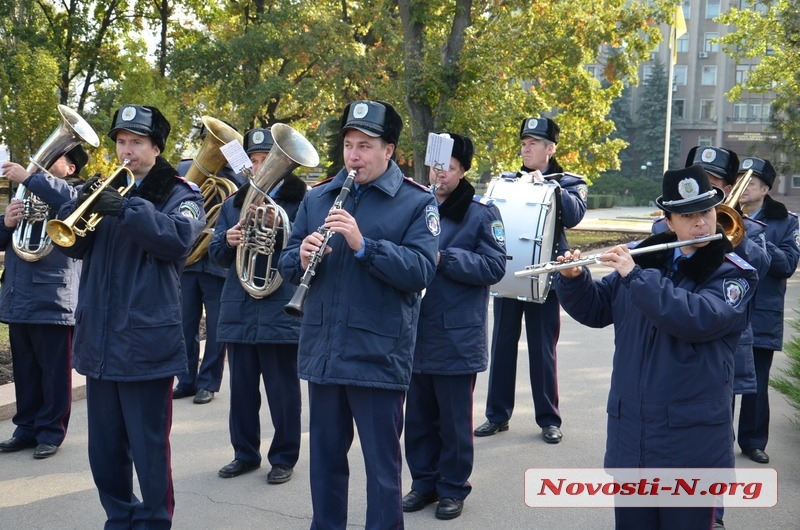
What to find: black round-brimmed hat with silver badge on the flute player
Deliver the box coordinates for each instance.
[656,164,725,214]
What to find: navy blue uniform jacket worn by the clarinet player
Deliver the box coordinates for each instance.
[279,161,439,390]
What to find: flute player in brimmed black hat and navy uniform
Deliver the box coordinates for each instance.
[553,165,758,530]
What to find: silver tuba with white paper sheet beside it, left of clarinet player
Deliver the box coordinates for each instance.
[236,123,319,298]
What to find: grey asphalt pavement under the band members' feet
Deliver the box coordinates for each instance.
[0,208,800,530]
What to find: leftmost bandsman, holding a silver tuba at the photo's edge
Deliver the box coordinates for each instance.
[0,145,89,459]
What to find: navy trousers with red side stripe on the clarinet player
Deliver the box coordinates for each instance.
[308,382,405,530]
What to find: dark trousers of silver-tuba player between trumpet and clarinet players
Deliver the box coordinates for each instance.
[228,343,302,468]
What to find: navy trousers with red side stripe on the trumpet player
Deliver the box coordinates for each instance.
[86,377,175,530]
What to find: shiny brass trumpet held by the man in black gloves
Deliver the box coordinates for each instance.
[47,160,136,247]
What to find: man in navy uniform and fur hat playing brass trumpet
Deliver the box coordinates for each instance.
[54,105,205,528]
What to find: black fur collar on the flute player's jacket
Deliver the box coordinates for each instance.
[633,226,733,283]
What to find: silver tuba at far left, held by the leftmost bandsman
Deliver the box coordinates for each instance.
[12,105,100,261]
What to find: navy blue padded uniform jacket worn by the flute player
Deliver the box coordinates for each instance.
[554,233,758,468]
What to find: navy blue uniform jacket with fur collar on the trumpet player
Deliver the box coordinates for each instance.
[58,157,205,381]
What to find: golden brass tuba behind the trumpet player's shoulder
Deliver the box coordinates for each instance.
[184,116,242,265]
